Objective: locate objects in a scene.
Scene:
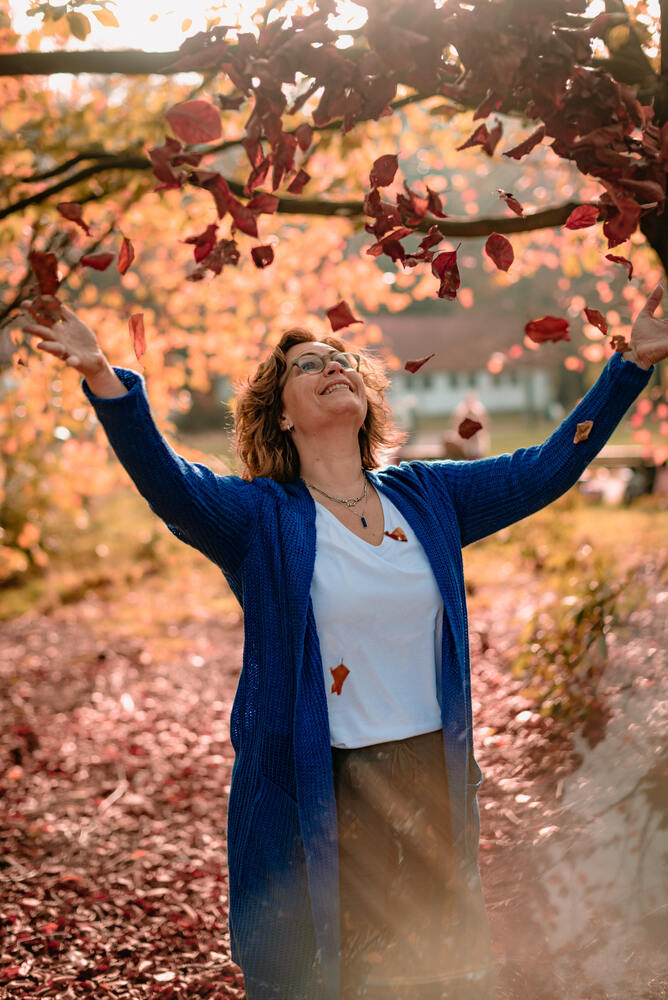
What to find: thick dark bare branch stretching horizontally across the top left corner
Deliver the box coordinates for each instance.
[0,49,181,76]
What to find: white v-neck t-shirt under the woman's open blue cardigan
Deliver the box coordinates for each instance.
[311,491,443,748]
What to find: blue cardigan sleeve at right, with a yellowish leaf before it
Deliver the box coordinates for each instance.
[412,354,654,546]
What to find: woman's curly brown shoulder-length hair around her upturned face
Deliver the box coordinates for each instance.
[234,326,406,483]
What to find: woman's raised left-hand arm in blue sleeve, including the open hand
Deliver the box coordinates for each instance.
[24,300,260,572]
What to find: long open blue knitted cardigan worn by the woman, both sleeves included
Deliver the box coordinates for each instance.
[82,354,653,1000]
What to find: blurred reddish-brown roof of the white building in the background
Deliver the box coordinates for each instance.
[364,308,572,372]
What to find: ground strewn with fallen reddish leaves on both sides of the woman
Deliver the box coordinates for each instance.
[0,552,668,1000]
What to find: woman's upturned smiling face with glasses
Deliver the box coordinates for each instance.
[281,341,367,432]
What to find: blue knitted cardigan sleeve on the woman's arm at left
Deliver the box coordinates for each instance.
[81,368,259,572]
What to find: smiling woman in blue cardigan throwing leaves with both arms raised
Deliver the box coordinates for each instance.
[24,286,668,1000]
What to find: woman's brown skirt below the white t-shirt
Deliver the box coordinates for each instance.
[332,729,492,1000]
